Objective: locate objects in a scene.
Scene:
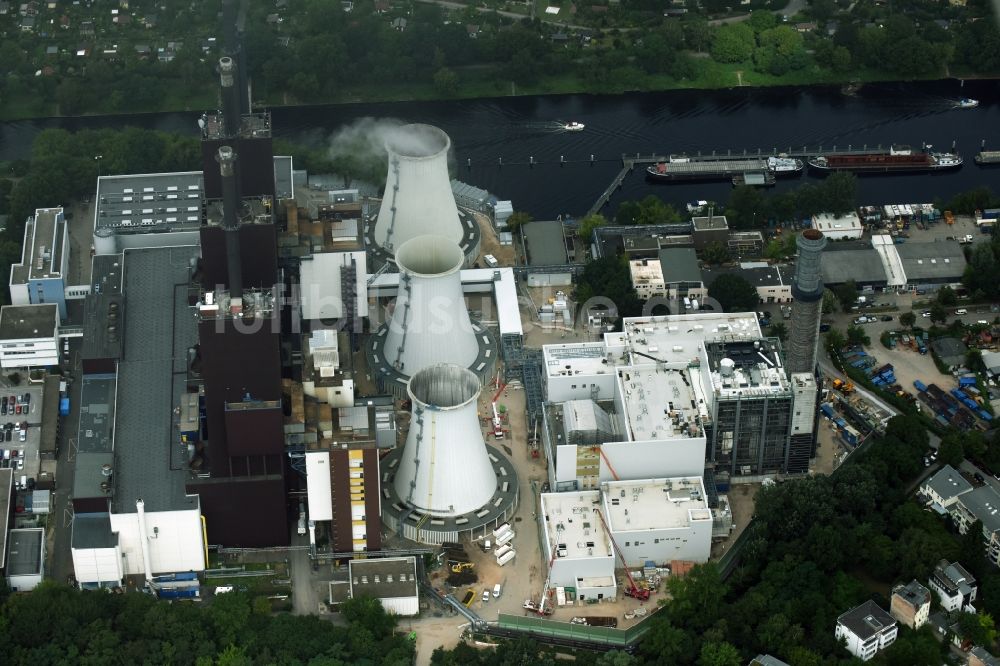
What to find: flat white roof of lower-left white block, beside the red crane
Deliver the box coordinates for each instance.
[541,490,614,559]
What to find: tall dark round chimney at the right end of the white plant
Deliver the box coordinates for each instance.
[785,229,826,375]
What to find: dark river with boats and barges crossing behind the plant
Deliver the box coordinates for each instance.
[0,80,1000,219]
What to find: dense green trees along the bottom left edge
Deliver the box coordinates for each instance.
[0,582,413,666]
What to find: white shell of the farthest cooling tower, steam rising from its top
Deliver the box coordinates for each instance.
[374,125,463,255]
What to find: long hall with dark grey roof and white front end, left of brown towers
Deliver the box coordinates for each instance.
[71,247,207,588]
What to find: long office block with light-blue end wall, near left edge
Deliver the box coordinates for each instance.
[10,208,72,320]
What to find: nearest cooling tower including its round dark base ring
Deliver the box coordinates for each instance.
[382,364,518,543]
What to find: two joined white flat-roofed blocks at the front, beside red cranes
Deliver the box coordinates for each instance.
[541,476,712,601]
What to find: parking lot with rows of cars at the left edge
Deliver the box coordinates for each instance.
[0,376,42,485]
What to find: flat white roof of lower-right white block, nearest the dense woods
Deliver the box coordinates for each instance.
[601,476,712,532]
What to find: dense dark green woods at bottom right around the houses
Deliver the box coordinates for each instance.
[433,417,1000,666]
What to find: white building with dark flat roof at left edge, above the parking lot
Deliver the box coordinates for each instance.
[0,303,59,370]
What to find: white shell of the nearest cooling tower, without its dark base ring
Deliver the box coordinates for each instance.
[393,364,497,517]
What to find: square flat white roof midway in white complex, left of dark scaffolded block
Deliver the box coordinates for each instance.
[618,364,704,441]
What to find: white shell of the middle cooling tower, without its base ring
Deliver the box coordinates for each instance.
[382,236,479,376]
